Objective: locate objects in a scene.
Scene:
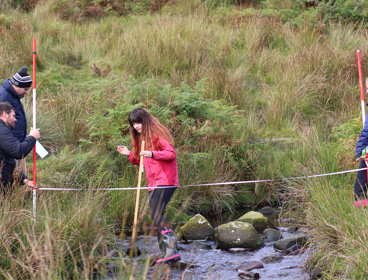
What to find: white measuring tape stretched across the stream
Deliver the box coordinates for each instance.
[38,167,367,191]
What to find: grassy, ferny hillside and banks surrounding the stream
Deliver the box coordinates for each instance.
[0,0,368,279]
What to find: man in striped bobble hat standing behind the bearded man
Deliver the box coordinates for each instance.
[0,66,32,174]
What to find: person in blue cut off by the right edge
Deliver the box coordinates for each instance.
[354,117,368,207]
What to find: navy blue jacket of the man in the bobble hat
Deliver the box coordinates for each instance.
[0,80,27,142]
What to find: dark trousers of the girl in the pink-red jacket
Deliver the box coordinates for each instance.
[149,186,177,229]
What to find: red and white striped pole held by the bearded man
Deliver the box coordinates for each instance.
[32,39,37,220]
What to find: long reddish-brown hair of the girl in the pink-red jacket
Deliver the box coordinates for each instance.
[128,108,174,157]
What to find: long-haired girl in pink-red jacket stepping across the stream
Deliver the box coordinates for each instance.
[117,108,180,263]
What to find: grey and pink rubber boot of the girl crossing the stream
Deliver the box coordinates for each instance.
[156,228,180,263]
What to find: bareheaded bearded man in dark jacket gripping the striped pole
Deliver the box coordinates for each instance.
[0,102,40,193]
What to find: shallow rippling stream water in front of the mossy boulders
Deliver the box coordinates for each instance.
[106,228,310,280]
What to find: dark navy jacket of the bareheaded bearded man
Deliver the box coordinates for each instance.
[0,120,36,187]
